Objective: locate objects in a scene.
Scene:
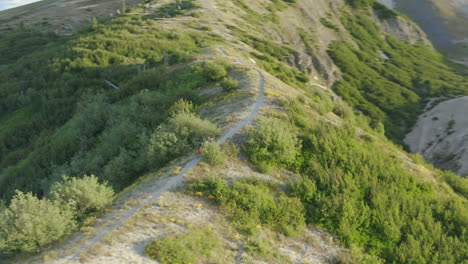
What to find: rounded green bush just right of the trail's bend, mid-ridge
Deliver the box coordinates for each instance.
[245,118,300,172]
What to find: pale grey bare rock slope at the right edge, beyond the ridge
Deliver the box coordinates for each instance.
[405,96,468,176]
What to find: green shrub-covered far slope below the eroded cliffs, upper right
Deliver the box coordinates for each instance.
[328,11,468,142]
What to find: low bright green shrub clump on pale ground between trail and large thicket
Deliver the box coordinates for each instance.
[189,178,305,235]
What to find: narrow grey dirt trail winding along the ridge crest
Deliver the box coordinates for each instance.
[54,56,265,263]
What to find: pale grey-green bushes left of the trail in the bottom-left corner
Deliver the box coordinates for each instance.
[0,175,114,256]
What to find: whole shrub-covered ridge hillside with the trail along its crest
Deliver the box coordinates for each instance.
[0,0,468,263]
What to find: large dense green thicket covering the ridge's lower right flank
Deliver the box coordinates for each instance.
[288,122,468,263]
